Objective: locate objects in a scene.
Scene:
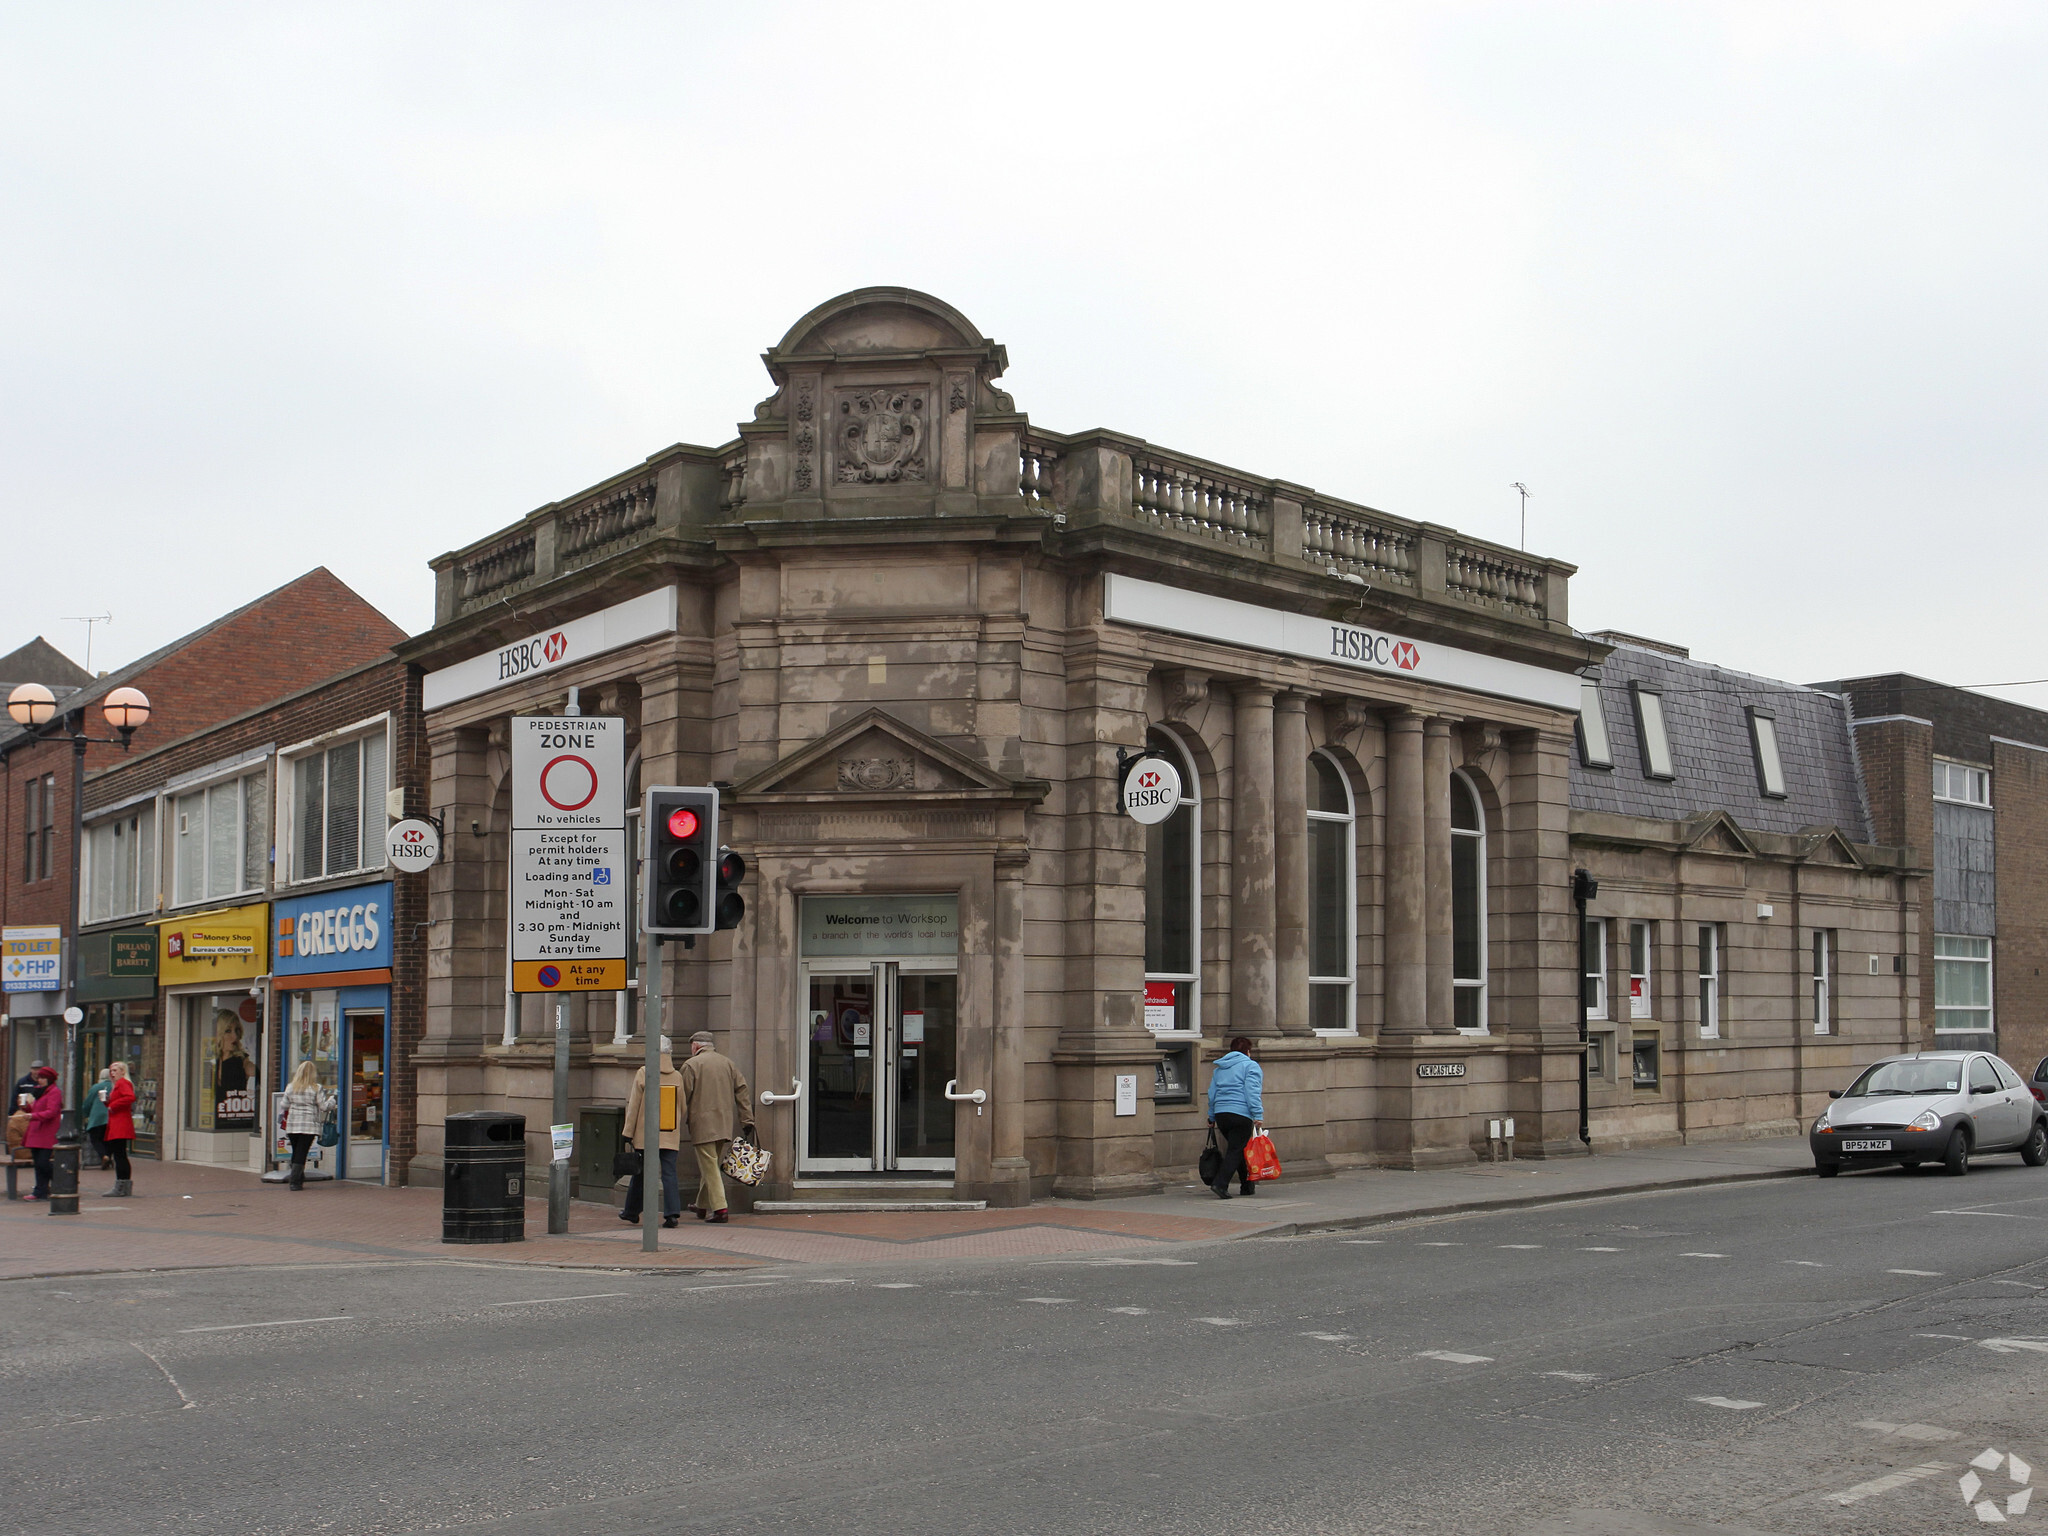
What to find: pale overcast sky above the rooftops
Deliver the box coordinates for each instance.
[0,0,2048,707]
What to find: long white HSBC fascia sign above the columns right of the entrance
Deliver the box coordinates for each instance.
[1104,573,1579,713]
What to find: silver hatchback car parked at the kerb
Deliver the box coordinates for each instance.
[1806,1051,2048,1180]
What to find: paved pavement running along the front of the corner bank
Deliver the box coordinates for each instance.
[0,1139,1812,1278]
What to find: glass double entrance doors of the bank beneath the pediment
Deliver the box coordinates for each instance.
[803,961,958,1174]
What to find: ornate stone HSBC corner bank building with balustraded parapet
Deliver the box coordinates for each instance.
[399,289,1900,1204]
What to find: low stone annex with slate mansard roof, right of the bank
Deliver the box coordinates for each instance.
[1571,631,1925,1147]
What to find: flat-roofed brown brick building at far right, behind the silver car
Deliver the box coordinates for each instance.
[1821,672,2048,1075]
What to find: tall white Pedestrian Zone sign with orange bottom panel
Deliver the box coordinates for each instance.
[510,715,627,991]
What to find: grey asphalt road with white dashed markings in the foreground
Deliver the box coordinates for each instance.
[0,1159,2048,1536]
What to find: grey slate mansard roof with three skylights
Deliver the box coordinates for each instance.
[1571,643,1870,842]
